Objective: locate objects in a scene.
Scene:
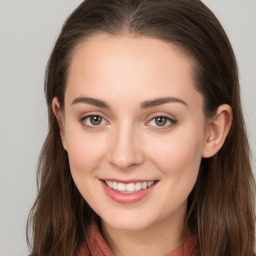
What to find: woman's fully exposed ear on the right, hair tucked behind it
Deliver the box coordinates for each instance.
[202,104,233,158]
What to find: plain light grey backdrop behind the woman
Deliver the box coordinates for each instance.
[0,0,256,256]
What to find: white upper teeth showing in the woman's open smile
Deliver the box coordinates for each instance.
[105,181,154,193]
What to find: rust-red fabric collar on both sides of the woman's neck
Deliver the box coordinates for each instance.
[78,223,196,256]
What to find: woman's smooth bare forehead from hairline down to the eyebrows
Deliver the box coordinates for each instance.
[66,35,201,110]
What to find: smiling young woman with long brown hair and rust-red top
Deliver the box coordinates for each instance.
[27,0,255,256]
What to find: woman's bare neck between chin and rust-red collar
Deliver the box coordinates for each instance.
[102,212,189,256]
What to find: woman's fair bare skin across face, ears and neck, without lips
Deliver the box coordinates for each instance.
[53,35,232,256]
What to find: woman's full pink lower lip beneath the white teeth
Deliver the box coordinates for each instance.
[101,181,157,204]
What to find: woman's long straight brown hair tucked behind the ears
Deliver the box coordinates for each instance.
[27,0,255,256]
